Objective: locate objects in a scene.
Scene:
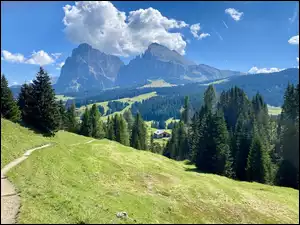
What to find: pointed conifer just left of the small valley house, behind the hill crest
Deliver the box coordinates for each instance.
[130,113,147,150]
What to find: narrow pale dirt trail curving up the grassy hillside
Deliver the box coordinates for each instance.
[1,139,95,224]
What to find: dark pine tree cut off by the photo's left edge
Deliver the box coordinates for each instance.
[1,74,21,122]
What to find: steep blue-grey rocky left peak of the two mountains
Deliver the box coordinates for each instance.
[55,44,124,92]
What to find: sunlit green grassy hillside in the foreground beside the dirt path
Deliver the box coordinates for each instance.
[1,119,299,224]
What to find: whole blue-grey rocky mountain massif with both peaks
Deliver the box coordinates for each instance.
[55,43,245,93]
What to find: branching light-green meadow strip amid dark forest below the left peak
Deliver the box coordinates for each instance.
[78,91,157,120]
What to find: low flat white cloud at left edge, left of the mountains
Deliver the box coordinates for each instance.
[1,50,55,66]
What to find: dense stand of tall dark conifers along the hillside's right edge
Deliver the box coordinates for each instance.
[163,84,299,189]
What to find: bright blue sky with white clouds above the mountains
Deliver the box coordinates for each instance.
[1,1,299,85]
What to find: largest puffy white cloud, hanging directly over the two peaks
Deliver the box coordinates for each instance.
[63,1,188,57]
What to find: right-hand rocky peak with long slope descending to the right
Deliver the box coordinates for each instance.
[116,43,243,86]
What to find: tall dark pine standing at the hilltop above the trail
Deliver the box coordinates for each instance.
[32,67,59,135]
